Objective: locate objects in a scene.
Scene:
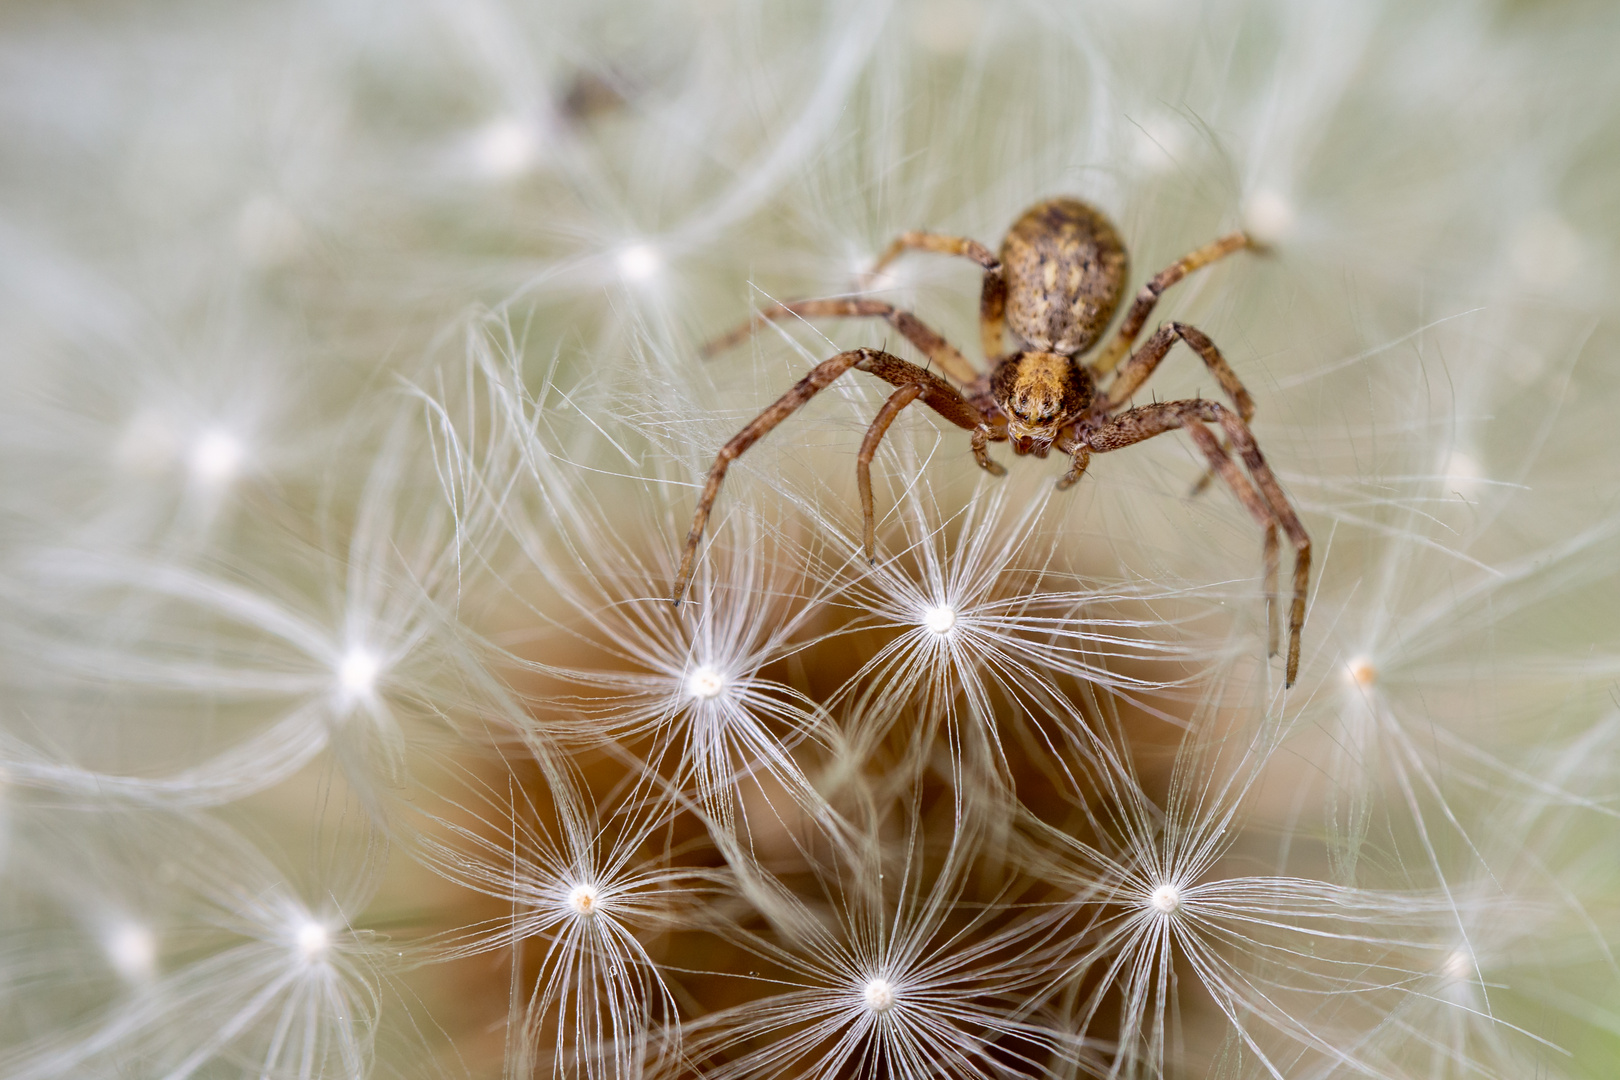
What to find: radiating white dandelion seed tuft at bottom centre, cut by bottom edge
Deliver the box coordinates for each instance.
[684,819,1082,1080]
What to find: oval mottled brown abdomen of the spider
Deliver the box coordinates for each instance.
[1001,196,1129,356]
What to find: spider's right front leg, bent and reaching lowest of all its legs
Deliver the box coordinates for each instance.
[1085,398,1311,687]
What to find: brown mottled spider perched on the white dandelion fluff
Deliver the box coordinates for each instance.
[672,198,1311,687]
